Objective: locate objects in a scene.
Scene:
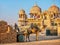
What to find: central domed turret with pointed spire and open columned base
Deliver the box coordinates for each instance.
[30,4,41,18]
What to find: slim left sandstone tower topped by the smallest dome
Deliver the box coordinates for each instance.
[18,9,27,26]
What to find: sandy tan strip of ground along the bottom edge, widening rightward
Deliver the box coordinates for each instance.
[0,39,60,45]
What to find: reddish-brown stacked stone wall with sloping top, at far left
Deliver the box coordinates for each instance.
[0,21,17,43]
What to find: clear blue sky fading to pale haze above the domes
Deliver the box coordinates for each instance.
[0,0,60,24]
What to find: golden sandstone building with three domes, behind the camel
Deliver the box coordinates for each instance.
[18,5,60,35]
